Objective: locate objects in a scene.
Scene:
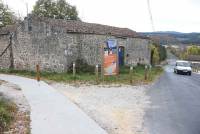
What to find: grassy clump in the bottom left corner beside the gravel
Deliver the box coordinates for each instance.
[0,98,17,133]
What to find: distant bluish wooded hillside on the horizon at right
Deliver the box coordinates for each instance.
[141,31,200,45]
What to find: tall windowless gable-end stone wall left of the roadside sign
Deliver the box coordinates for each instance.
[14,18,79,72]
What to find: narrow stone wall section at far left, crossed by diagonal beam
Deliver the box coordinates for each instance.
[0,35,10,69]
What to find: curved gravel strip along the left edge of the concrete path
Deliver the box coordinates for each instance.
[0,81,30,134]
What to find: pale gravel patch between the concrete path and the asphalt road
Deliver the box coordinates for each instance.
[51,83,150,134]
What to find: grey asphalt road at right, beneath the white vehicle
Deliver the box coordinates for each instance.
[144,59,200,134]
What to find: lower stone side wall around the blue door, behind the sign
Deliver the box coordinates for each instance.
[81,35,150,65]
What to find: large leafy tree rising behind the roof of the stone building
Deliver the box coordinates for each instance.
[32,0,79,20]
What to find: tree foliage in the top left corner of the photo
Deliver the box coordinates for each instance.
[0,1,15,26]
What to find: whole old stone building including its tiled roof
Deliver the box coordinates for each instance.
[0,16,150,72]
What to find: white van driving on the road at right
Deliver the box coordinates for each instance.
[174,60,192,75]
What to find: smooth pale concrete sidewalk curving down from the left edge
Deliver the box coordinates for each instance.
[0,75,107,134]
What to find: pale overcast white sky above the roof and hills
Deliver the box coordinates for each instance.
[3,0,200,33]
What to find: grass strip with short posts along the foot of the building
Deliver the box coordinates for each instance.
[0,65,163,84]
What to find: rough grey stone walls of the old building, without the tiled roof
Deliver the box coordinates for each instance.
[1,19,150,72]
